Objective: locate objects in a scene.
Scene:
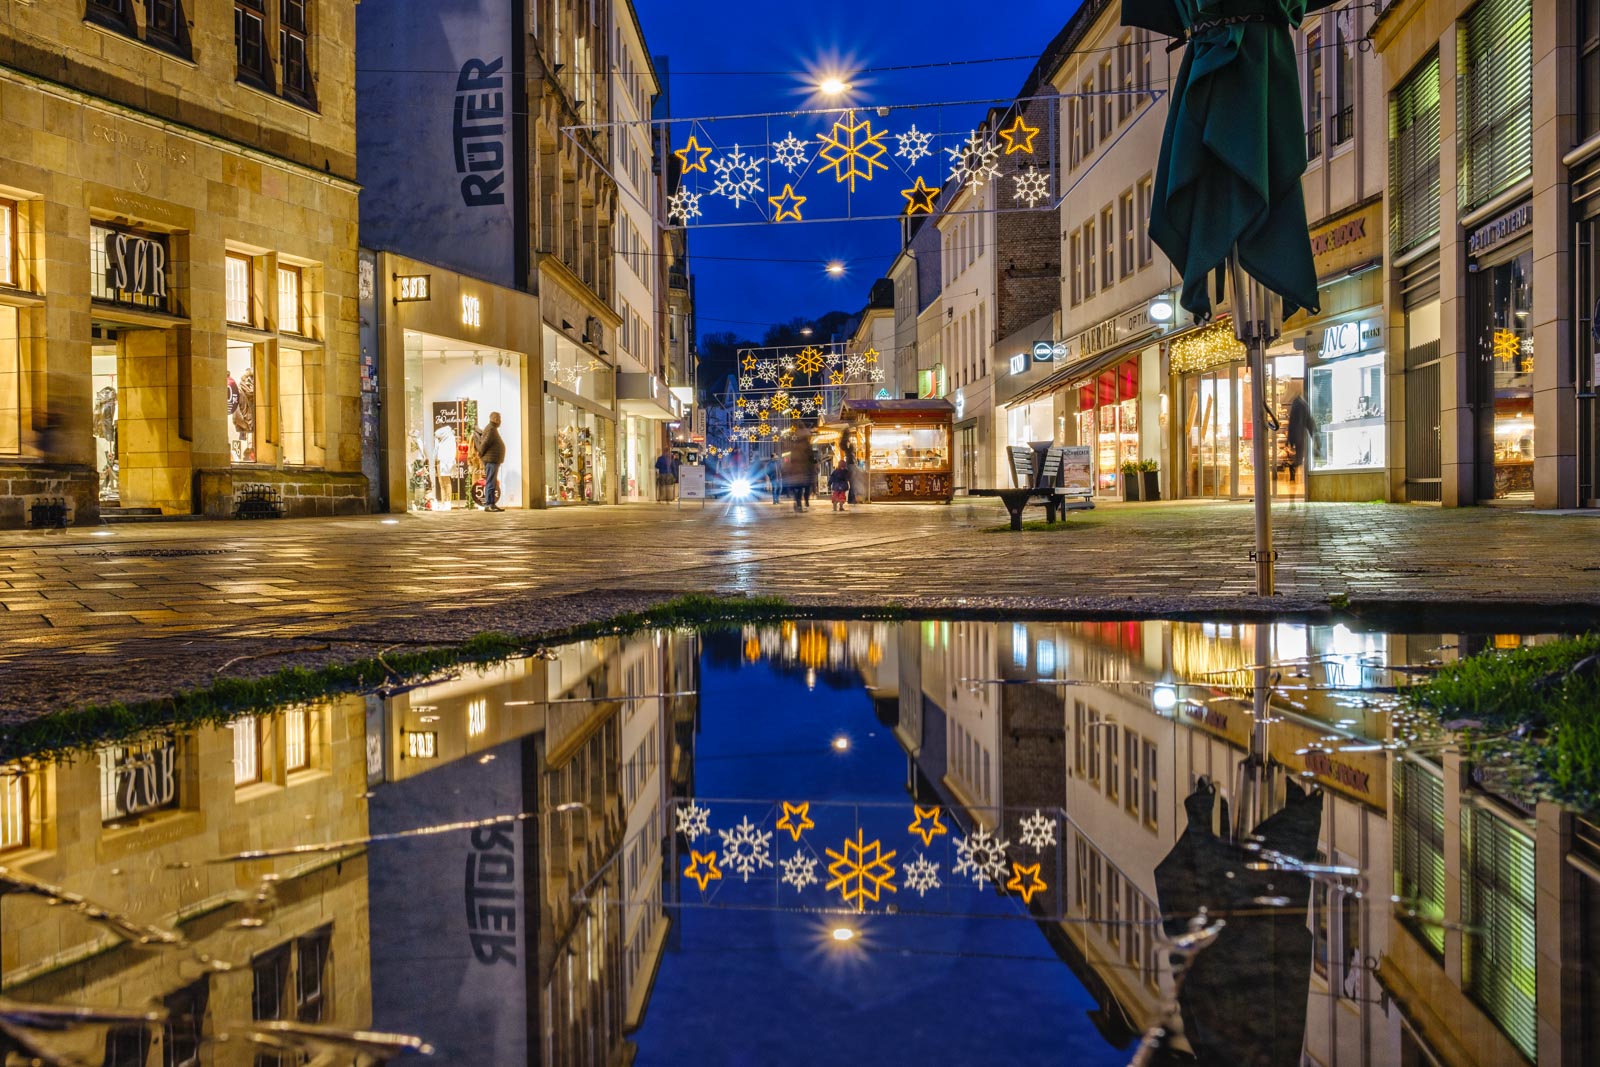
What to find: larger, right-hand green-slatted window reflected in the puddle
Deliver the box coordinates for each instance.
[1461,808,1539,1061]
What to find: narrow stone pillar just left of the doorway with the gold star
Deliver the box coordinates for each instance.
[1438,26,1478,507]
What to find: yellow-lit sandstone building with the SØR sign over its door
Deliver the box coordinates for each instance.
[0,0,366,525]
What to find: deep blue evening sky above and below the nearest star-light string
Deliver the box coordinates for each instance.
[635,0,1078,336]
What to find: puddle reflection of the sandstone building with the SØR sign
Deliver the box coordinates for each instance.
[0,701,371,1064]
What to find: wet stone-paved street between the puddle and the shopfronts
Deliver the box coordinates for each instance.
[0,501,1600,718]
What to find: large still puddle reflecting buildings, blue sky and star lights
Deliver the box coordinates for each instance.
[0,622,1600,1067]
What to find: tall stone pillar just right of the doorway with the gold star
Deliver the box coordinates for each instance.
[1533,0,1578,507]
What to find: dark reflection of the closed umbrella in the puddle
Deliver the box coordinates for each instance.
[1155,781,1322,1067]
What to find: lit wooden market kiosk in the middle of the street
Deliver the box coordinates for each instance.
[838,400,955,504]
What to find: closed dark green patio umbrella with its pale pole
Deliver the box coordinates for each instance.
[1122,0,1333,595]
